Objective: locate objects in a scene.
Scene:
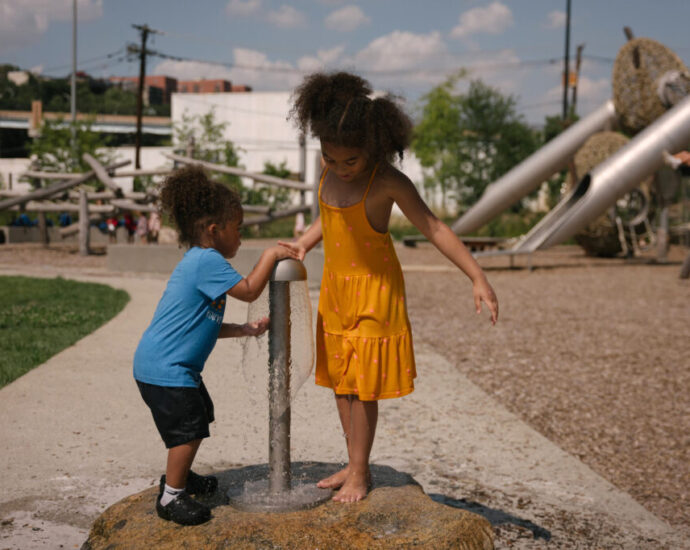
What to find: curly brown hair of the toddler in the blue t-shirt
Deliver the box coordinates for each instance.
[160,164,243,246]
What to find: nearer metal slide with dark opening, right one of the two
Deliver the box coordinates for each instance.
[510,96,690,254]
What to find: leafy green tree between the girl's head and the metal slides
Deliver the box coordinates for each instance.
[412,75,538,213]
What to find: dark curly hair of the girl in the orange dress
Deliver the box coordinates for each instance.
[290,72,412,161]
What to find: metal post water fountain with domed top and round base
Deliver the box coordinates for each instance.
[228,258,332,512]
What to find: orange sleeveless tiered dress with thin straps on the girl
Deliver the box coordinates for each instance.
[316,168,416,401]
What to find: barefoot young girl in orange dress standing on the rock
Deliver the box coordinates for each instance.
[280,72,498,502]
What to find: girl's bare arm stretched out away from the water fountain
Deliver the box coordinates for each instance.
[385,174,498,324]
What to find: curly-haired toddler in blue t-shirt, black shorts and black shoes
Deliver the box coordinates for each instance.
[134,166,296,525]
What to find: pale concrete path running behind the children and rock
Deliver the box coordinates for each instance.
[0,268,690,550]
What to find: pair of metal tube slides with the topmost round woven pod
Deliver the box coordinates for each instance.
[452,38,690,262]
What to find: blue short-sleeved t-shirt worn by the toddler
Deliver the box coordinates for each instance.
[134,247,242,387]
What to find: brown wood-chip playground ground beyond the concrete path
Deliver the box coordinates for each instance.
[0,244,690,533]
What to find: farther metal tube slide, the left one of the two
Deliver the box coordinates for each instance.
[452,100,616,235]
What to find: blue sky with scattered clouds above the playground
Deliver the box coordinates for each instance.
[0,0,690,125]
